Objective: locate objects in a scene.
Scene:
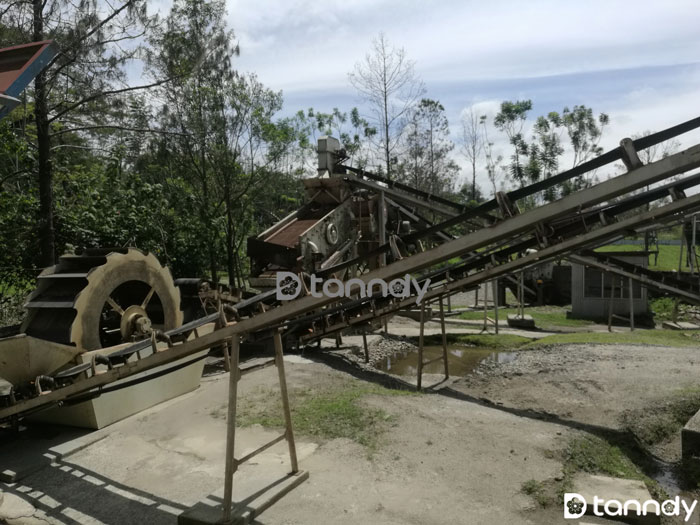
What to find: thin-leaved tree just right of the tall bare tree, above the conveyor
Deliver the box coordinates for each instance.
[399,98,459,194]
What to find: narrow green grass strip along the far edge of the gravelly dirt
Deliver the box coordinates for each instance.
[526,329,700,348]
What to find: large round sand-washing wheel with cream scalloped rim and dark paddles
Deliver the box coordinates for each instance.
[21,248,183,350]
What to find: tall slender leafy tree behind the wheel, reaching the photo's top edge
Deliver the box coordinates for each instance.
[149,0,239,282]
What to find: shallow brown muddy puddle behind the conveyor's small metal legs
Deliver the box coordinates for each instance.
[375,346,517,376]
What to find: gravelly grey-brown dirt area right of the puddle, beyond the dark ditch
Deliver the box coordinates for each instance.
[452,344,700,461]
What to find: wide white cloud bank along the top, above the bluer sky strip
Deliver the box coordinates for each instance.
[228,0,700,90]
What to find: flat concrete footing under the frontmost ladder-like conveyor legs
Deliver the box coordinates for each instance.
[177,470,309,525]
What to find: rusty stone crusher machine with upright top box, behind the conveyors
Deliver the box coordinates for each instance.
[248,137,464,291]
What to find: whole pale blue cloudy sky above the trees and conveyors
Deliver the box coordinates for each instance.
[227,0,700,185]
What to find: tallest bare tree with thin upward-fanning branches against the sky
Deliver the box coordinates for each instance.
[349,33,425,178]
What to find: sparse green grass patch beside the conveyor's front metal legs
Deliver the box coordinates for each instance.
[237,384,416,454]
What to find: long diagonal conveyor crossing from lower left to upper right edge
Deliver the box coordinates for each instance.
[0,119,700,420]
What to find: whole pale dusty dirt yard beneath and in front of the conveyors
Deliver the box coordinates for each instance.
[0,320,700,525]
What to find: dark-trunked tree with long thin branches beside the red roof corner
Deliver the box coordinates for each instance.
[0,0,165,266]
